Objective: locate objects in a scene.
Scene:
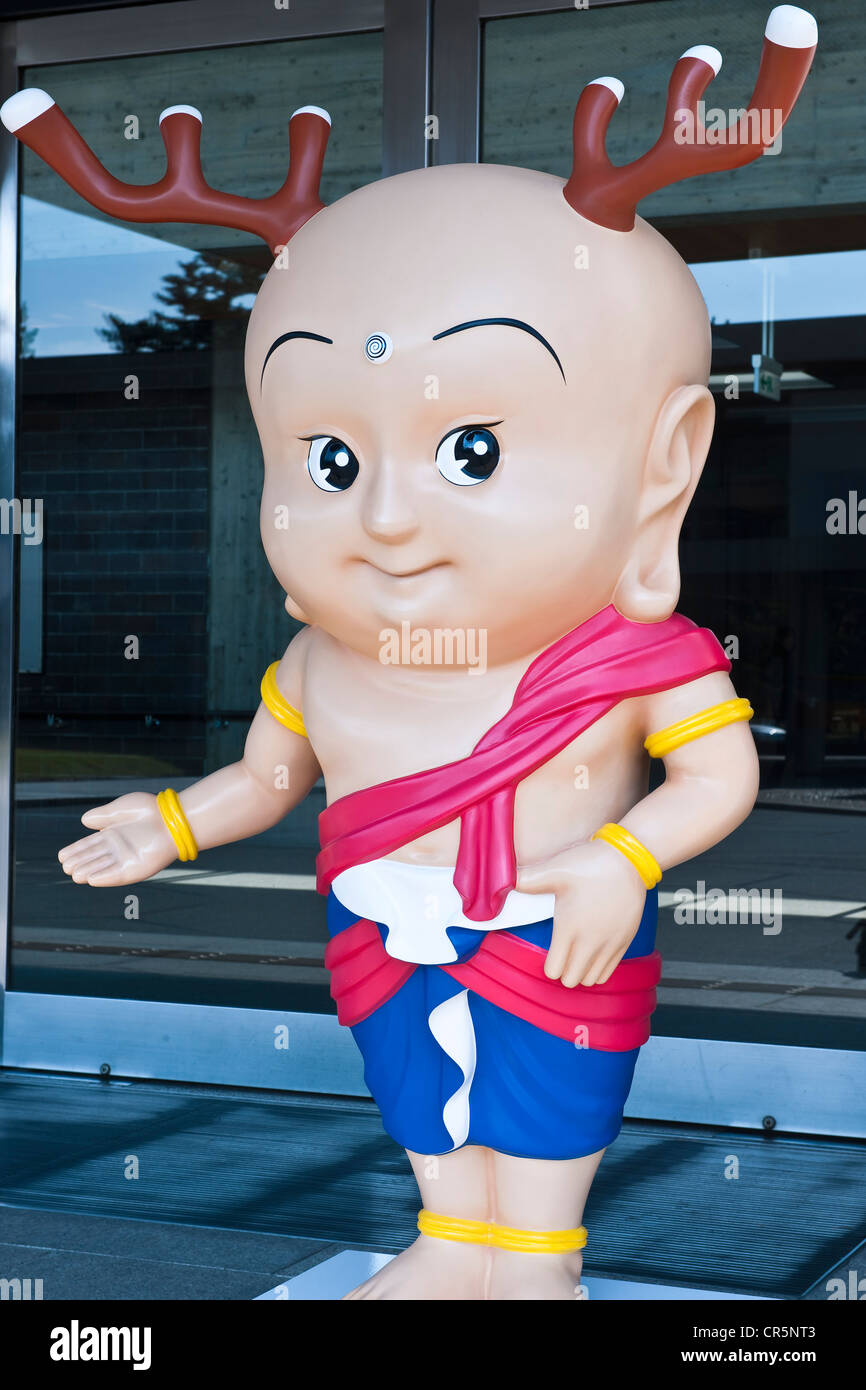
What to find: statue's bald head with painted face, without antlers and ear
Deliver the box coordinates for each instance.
[246,164,712,660]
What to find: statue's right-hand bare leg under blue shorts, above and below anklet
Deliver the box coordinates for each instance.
[487,1150,605,1301]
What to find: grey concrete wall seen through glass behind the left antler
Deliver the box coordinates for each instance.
[22,33,382,259]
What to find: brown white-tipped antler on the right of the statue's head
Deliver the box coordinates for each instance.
[563,4,817,232]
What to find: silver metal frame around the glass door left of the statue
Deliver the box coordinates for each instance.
[0,0,431,1094]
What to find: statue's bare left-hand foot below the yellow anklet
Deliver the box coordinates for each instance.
[346,1236,491,1302]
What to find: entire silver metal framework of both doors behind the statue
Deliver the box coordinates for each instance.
[0,0,866,1137]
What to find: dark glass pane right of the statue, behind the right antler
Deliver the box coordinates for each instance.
[481,0,866,1048]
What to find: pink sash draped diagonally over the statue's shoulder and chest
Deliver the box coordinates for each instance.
[316,605,731,922]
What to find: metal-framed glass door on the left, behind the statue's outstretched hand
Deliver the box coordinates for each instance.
[0,4,427,1091]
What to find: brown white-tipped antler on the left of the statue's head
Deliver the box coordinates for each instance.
[0,88,331,253]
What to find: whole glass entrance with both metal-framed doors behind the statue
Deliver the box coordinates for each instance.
[0,0,866,1134]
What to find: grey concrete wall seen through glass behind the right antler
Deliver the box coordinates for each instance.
[482,0,866,220]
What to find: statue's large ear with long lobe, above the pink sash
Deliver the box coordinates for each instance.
[613,386,716,623]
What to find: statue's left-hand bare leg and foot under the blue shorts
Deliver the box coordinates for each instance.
[346,1144,494,1301]
